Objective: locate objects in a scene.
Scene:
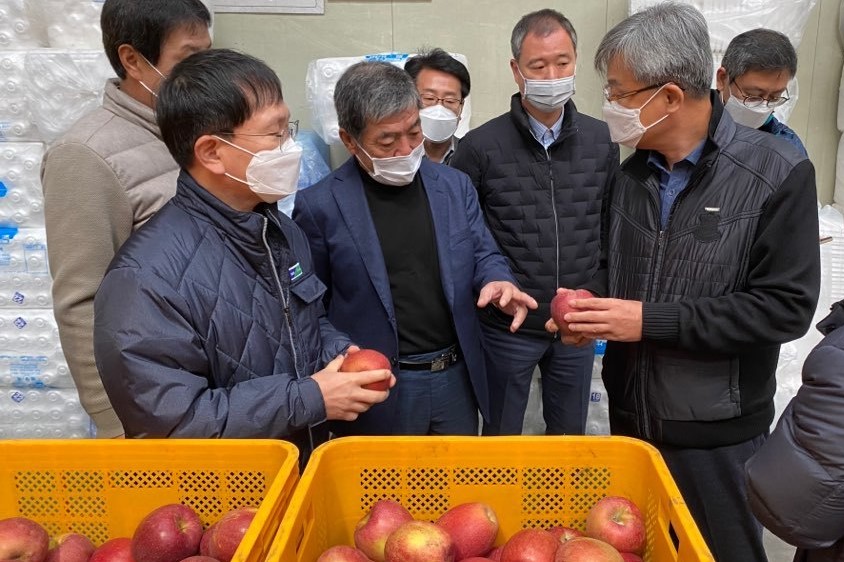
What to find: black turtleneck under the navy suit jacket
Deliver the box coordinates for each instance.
[358,165,457,355]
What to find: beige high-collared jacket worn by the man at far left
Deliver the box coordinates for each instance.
[41,80,178,437]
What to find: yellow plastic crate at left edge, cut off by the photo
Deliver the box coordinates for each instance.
[0,439,299,562]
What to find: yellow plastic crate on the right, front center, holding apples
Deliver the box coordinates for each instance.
[267,436,714,562]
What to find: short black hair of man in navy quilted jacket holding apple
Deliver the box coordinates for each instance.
[155,49,284,168]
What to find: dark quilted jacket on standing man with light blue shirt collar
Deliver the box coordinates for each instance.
[451,94,618,338]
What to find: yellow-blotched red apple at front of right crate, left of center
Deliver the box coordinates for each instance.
[384,521,456,562]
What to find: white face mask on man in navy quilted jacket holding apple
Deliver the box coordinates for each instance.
[215,135,302,203]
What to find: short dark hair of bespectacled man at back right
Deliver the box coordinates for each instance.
[721,27,797,82]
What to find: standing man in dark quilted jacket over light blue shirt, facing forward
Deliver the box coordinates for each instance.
[451,9,618,435]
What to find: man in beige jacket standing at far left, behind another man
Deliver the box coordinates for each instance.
[41,0,211,438]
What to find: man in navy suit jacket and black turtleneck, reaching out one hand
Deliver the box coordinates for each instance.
[293,62,536,435]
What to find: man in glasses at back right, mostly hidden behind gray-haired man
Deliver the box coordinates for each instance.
[716,28,807,156]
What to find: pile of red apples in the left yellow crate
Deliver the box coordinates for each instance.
[0,504,257,562]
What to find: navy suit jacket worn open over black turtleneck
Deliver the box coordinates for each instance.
[293,157,515,435]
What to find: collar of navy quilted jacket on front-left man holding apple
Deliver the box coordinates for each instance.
[173,169,285,244]
